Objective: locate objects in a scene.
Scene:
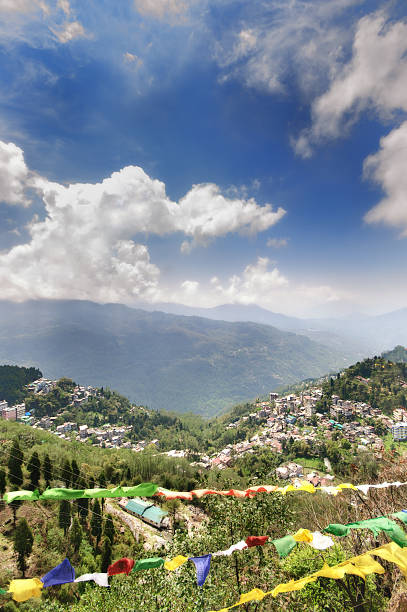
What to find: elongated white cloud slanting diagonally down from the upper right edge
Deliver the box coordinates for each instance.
[294,12,407,157]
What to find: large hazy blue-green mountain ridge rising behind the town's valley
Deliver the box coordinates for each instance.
[0,301,351,414]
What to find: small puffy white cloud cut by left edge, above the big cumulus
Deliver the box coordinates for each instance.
[0,141,30,206]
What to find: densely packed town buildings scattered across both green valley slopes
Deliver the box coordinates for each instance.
[0,378,407,484]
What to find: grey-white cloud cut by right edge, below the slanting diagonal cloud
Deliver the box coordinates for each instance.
[364,121,407,237]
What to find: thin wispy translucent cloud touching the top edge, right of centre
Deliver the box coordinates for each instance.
[216,0,360,94]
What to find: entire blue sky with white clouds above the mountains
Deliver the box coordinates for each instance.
[0,0,407,317]
